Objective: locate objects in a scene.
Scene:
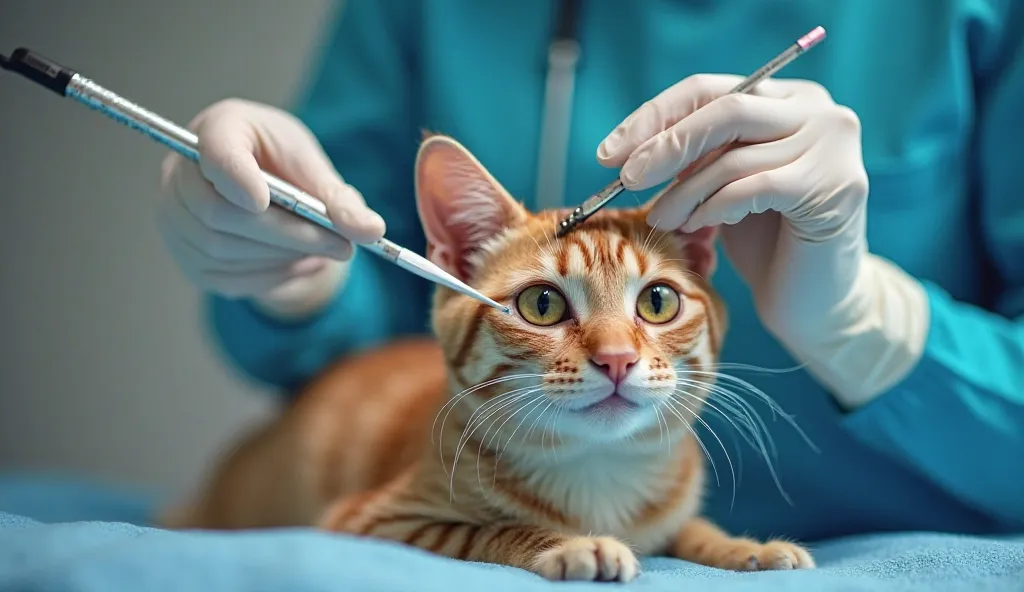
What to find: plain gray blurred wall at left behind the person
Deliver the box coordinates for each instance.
[0,0,338,494]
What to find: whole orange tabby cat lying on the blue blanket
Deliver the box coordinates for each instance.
[161,136,814,582]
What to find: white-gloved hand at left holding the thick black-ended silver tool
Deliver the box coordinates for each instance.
[158,99,385,318]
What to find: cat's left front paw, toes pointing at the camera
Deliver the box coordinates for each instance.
[534,537,640,582]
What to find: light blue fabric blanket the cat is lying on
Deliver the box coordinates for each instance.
[0,477,1024,592]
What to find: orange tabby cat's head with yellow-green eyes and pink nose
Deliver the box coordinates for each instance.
[416,135,726,440]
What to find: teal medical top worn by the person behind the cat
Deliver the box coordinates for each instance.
[209,0,1024,540]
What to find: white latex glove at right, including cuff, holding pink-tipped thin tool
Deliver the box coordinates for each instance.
[597,75,929,408]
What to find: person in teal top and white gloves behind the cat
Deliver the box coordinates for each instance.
[160,0,1024,540]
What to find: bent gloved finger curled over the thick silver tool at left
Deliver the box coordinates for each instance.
[197,112,270,212]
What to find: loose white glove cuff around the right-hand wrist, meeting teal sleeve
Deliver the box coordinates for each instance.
[794,254,930,411]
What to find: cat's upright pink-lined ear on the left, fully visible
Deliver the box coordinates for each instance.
[416,135,529,281]
